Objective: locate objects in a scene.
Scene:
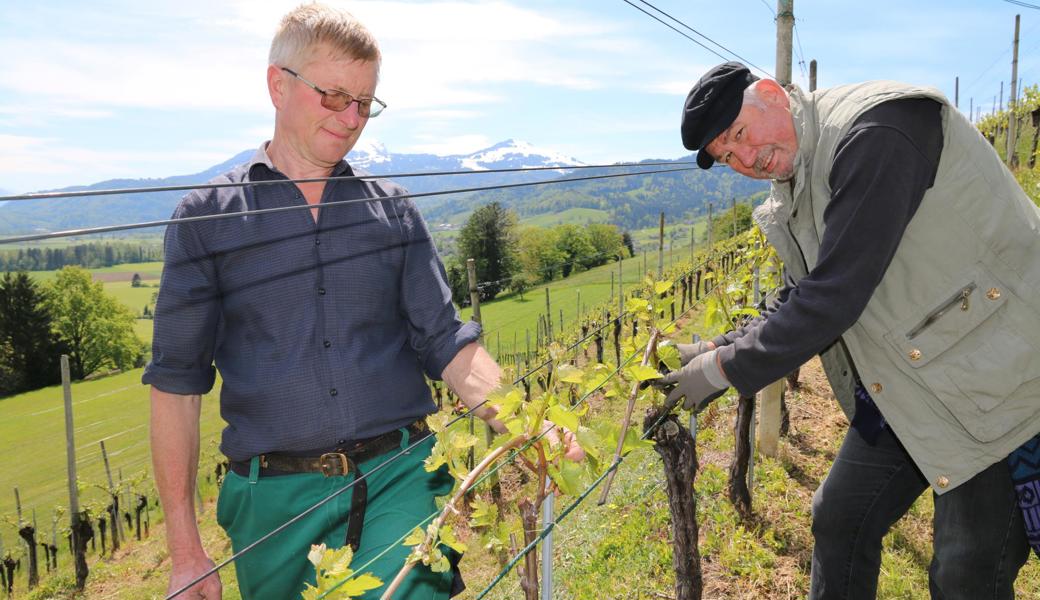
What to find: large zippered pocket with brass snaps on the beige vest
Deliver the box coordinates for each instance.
[885,264,1040,442]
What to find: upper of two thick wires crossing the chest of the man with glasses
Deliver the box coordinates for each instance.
[0,161,696,202]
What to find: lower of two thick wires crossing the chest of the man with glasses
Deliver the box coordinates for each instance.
[0,167,697,245]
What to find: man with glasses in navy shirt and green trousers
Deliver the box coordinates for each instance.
[144,4,580,600]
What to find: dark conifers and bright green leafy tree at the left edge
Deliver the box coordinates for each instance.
[0,266,147,396]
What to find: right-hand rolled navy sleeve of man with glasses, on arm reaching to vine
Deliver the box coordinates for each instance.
[400,201,480,380]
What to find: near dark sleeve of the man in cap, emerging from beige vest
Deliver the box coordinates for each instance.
[716,99,942,409]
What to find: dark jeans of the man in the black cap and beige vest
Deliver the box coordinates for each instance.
[809,428,1029,600]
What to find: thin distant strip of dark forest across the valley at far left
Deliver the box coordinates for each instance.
[0,242,162,271]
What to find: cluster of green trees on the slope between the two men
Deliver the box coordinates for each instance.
[445,202,633,306]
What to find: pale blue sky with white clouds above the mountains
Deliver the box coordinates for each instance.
[0,0,1040,192]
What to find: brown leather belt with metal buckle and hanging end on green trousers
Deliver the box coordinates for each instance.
[231,420,430,552]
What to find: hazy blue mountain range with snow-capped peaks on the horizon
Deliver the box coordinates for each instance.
[0,138,764,235]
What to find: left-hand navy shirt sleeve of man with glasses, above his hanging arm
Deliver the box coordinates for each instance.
[141,194,220,394]
